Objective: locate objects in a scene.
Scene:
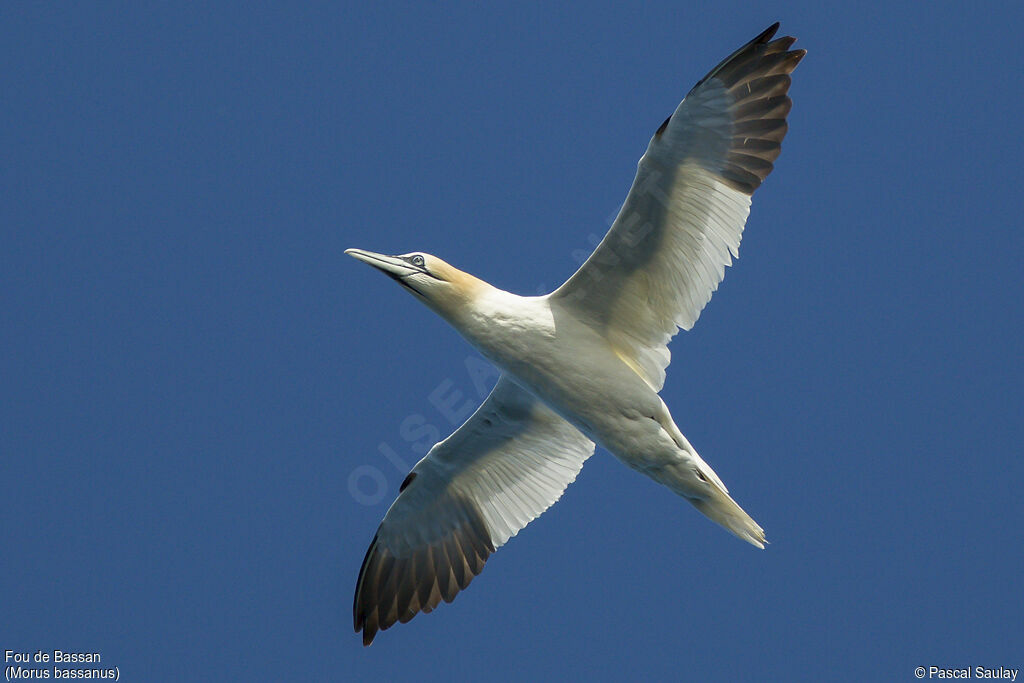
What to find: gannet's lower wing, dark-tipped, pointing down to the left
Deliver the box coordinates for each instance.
[353,376,594,645]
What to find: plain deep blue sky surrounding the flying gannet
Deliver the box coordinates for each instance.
[0,0,1024,681]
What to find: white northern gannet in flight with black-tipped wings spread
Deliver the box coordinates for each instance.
[345,24,806,645]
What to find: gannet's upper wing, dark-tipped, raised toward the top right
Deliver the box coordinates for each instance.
[552,24,806,390]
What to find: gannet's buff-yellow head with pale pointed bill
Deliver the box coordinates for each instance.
[345,249,486,319]
